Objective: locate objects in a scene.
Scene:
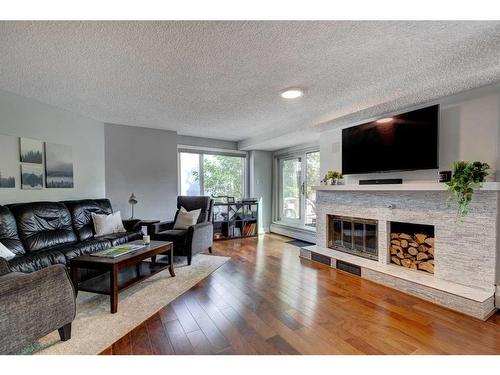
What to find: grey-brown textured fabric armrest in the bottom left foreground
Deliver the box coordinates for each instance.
[0,265,76,353]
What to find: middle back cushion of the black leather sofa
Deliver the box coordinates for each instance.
[9,202,77,252]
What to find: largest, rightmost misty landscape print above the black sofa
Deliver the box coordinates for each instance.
[45,143,74,188]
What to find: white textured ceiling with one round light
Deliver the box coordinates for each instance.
[0,21,500,149]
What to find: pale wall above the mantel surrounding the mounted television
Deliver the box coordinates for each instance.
[320,93,500,183]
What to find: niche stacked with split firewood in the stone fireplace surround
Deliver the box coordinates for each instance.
[389,221,435,274]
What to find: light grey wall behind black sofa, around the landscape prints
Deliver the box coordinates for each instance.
[0,90,105,204]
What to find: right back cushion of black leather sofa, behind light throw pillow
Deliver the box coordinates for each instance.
[63,199,113,241]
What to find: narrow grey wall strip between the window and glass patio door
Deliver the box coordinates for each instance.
[249,151,273,232]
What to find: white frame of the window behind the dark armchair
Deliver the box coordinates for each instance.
[177,145,248,198]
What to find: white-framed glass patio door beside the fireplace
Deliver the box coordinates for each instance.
[277,150,320,228]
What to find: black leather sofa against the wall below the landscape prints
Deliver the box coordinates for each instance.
[0,199,142,278]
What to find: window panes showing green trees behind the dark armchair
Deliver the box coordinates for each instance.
[179,150,245,198]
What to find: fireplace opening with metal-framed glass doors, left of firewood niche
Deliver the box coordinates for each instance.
[327,215,378,260]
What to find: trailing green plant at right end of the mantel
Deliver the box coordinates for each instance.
[446,161,490,220]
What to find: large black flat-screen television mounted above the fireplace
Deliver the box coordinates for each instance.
[342,105,439,174]
